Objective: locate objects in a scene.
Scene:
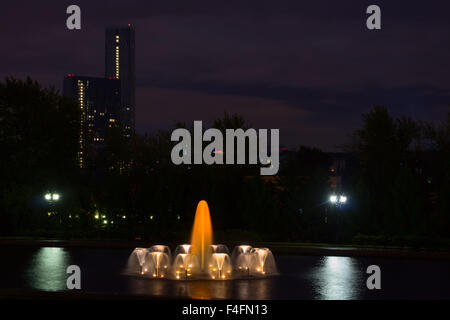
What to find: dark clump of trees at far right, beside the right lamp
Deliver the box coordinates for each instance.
[342,107,450,245]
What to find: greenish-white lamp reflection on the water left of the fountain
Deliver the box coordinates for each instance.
[26,247,69,291]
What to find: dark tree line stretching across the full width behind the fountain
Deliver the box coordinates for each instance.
[0,79,450,248]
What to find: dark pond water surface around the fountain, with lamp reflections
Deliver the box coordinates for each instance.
[0,247,450,300]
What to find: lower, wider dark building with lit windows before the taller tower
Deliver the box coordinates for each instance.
[63,74,122,168]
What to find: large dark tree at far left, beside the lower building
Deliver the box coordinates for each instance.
[0,78,79,232]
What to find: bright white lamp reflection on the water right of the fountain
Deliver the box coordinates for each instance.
[313,256,365,300]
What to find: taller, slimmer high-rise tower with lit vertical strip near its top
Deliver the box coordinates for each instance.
[105,25,136,136]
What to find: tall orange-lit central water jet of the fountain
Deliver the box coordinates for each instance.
[191,200,212,271]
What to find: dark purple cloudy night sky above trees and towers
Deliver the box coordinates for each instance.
[0,0,450,151]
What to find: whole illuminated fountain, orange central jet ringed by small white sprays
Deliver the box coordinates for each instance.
[126,200,277,280]
